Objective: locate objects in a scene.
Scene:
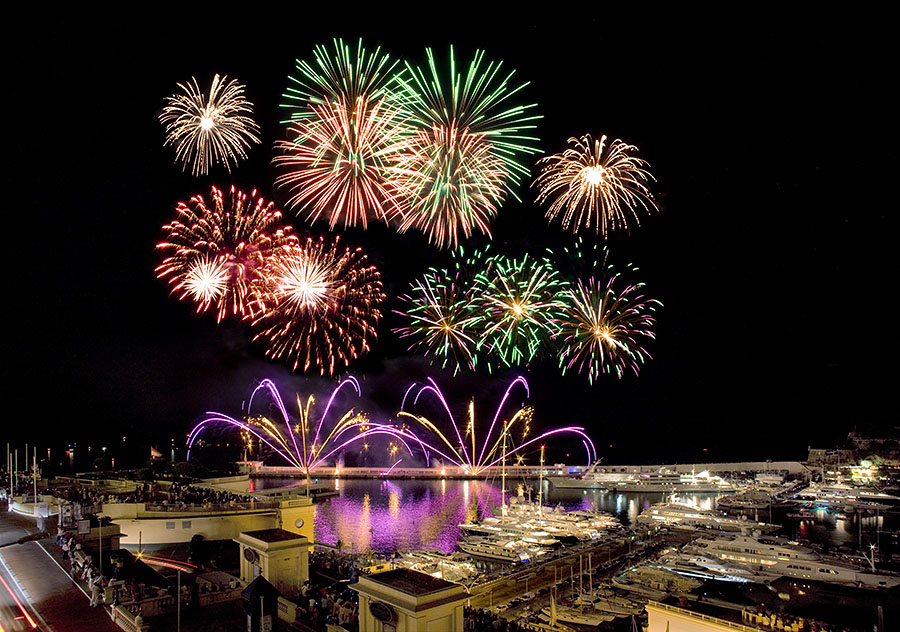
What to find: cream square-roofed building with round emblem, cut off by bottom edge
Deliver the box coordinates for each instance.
[352,568,469,632]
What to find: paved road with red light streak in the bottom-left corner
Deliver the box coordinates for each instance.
[0,506,121,632]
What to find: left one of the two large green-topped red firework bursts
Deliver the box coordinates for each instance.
[274,40,412,228]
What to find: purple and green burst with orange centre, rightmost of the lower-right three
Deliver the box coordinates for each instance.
[557,274,662,383]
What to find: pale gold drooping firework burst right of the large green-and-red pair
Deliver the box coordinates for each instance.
[534,135,659,236]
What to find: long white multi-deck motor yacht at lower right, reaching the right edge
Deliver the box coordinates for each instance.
[684,535,900,588]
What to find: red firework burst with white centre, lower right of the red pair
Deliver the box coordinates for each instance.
[253,237,384,375]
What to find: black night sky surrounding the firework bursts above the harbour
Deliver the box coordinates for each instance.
[3,14,900,462]
